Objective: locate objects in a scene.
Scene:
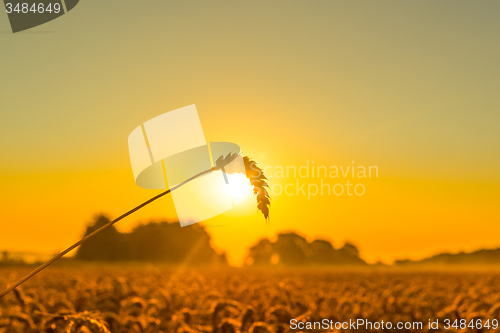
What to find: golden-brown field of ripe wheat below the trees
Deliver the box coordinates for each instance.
[0,266,500,333]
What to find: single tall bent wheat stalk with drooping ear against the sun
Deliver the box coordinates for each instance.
[0,153,269,299]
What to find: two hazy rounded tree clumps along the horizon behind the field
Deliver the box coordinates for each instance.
[76,215,366,266]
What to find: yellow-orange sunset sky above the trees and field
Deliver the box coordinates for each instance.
[0,0,500,264]
